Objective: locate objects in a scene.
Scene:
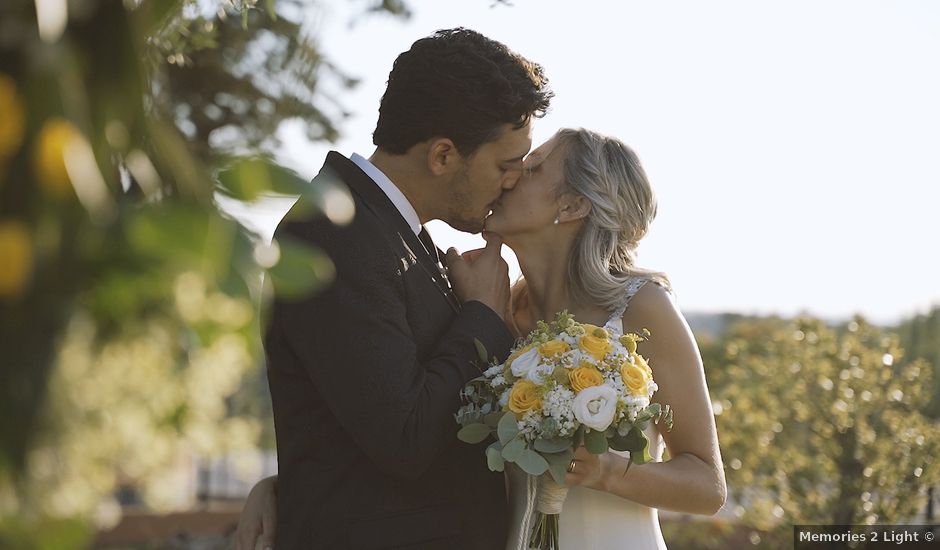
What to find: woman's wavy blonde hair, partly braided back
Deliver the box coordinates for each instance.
[514,128,669,311]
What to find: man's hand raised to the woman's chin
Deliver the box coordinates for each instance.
[447,234,509,321]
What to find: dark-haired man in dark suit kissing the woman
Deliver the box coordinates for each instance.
[265,28,551,550]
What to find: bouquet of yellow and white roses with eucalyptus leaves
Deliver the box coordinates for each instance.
[456,312,672,550]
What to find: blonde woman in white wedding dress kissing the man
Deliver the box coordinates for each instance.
[238,129,726,550]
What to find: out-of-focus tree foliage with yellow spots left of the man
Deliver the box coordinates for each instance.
[0,0,407,547]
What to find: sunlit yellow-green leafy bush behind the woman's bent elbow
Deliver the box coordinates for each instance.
[703,318,940,544]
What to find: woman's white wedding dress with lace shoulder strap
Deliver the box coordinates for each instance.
[506,278,666,550]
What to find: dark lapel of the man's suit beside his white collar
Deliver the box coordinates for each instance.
[326,151,460,311]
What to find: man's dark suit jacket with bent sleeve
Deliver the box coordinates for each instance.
[265,152,512,550]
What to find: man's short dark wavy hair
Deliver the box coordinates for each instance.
[372,28,553,155]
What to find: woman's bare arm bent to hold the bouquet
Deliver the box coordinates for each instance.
[567,284,727,515]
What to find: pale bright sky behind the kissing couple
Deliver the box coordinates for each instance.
[228,0,940,323]
